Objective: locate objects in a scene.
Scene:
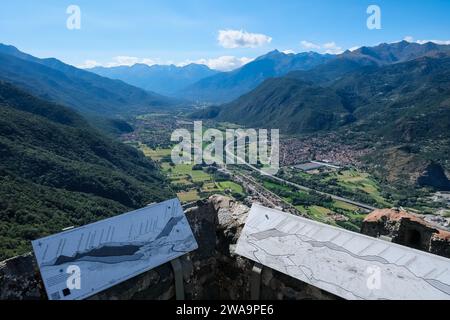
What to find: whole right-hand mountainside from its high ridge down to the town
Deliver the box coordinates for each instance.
[192,41,450,189]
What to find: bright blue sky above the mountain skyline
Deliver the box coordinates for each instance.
[0,0,450,69]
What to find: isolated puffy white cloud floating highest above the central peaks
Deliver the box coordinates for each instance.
[217,30,272,49]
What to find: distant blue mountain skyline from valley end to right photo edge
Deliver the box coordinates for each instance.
[88,41,448,104]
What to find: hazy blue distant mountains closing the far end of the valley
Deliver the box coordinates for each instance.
[87,50,333,103]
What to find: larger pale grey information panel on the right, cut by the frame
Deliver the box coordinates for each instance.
[236,205,450,300]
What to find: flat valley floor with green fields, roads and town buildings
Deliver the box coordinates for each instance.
[124,114,450,231]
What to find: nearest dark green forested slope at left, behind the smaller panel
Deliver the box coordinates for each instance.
[0,81,172,260]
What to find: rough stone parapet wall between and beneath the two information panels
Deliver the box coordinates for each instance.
[0,196,336,300]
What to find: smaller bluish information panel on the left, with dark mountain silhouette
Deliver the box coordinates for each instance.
[32,199,198,300]
